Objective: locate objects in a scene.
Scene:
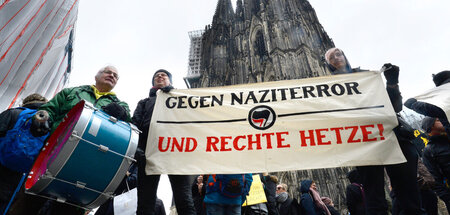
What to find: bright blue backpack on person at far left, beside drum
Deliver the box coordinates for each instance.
[0,108,48,173]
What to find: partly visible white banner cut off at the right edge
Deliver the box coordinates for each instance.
[414,83,450,119]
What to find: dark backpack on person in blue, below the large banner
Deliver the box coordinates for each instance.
[209,174,246,198]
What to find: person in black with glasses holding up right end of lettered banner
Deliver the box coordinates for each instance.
[325,48,425,215]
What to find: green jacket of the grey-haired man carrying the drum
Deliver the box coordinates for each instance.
[39,85,131,132]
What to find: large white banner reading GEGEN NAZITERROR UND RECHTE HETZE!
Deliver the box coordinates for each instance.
[146,72,405,174]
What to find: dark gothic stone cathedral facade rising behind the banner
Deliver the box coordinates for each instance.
[185,0,334,88]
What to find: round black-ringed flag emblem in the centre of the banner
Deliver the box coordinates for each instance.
[248,105,277,130]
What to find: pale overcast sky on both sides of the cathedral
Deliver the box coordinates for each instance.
[69,0,450,212]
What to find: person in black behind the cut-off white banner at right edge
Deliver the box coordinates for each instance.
[405,70,450,135]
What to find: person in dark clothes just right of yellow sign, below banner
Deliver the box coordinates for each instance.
[275,184,299,215]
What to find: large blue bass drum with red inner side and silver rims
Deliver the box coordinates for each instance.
[25,101,139,209]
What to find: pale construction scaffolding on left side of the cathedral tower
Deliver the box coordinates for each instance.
[184,30,204,88]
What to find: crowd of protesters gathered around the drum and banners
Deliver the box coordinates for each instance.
[0,48,450,215]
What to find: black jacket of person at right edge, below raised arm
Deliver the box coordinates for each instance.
[423,135,450,203]
